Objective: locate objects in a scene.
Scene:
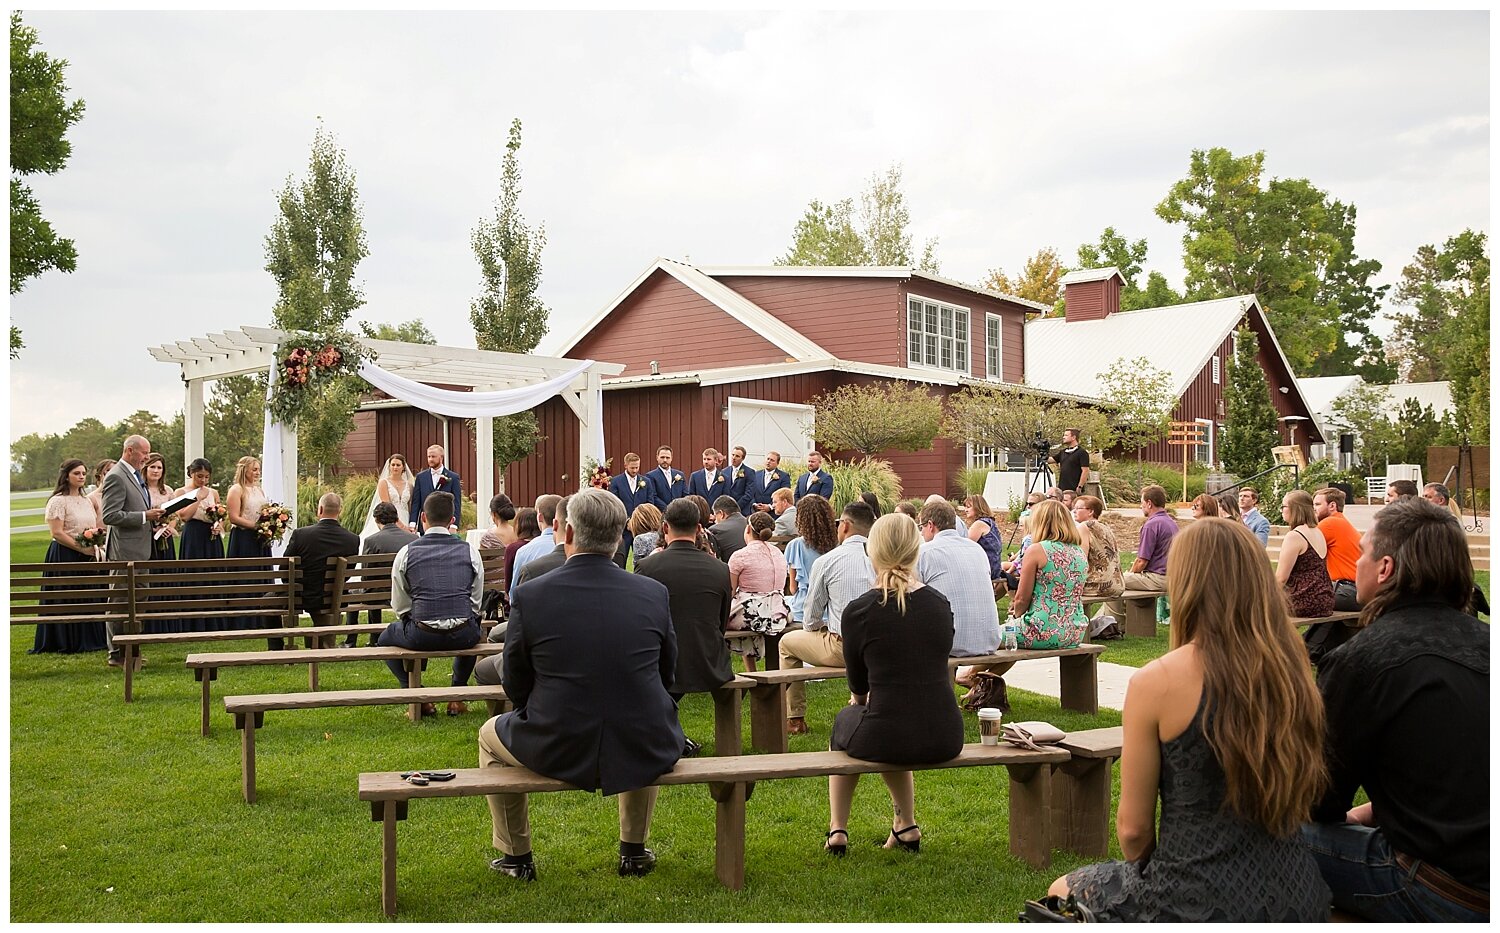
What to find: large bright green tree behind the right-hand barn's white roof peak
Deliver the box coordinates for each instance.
[1157,149,1386,375]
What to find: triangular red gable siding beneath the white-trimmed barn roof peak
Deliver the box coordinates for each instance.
[569,270,786,375]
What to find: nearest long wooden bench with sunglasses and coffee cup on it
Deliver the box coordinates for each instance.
[359,744,1070,917]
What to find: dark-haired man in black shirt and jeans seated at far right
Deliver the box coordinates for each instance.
[1302,498,1490,923]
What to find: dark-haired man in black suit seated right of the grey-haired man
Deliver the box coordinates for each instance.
[636,500,732,758]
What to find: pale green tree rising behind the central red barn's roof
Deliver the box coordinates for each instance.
[776,164,938,273]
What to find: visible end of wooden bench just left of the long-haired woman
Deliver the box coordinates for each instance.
[1052,726,1125,858]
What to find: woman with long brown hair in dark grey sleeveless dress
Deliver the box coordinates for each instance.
[1050,519,1329,923]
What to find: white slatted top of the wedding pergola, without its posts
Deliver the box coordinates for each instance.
[147,326,626,389]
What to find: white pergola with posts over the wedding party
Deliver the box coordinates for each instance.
[147,326,624,528]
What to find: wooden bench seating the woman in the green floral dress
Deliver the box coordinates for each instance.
[740,645,1104,755]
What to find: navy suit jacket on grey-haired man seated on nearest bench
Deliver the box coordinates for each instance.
[495,554,683,797]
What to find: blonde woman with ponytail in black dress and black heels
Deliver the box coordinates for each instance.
[825,515,963,855]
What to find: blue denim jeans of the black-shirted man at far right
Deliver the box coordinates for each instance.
[1302,824,1490,923]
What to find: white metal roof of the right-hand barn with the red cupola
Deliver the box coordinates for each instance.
[1026,296,1313,429]
